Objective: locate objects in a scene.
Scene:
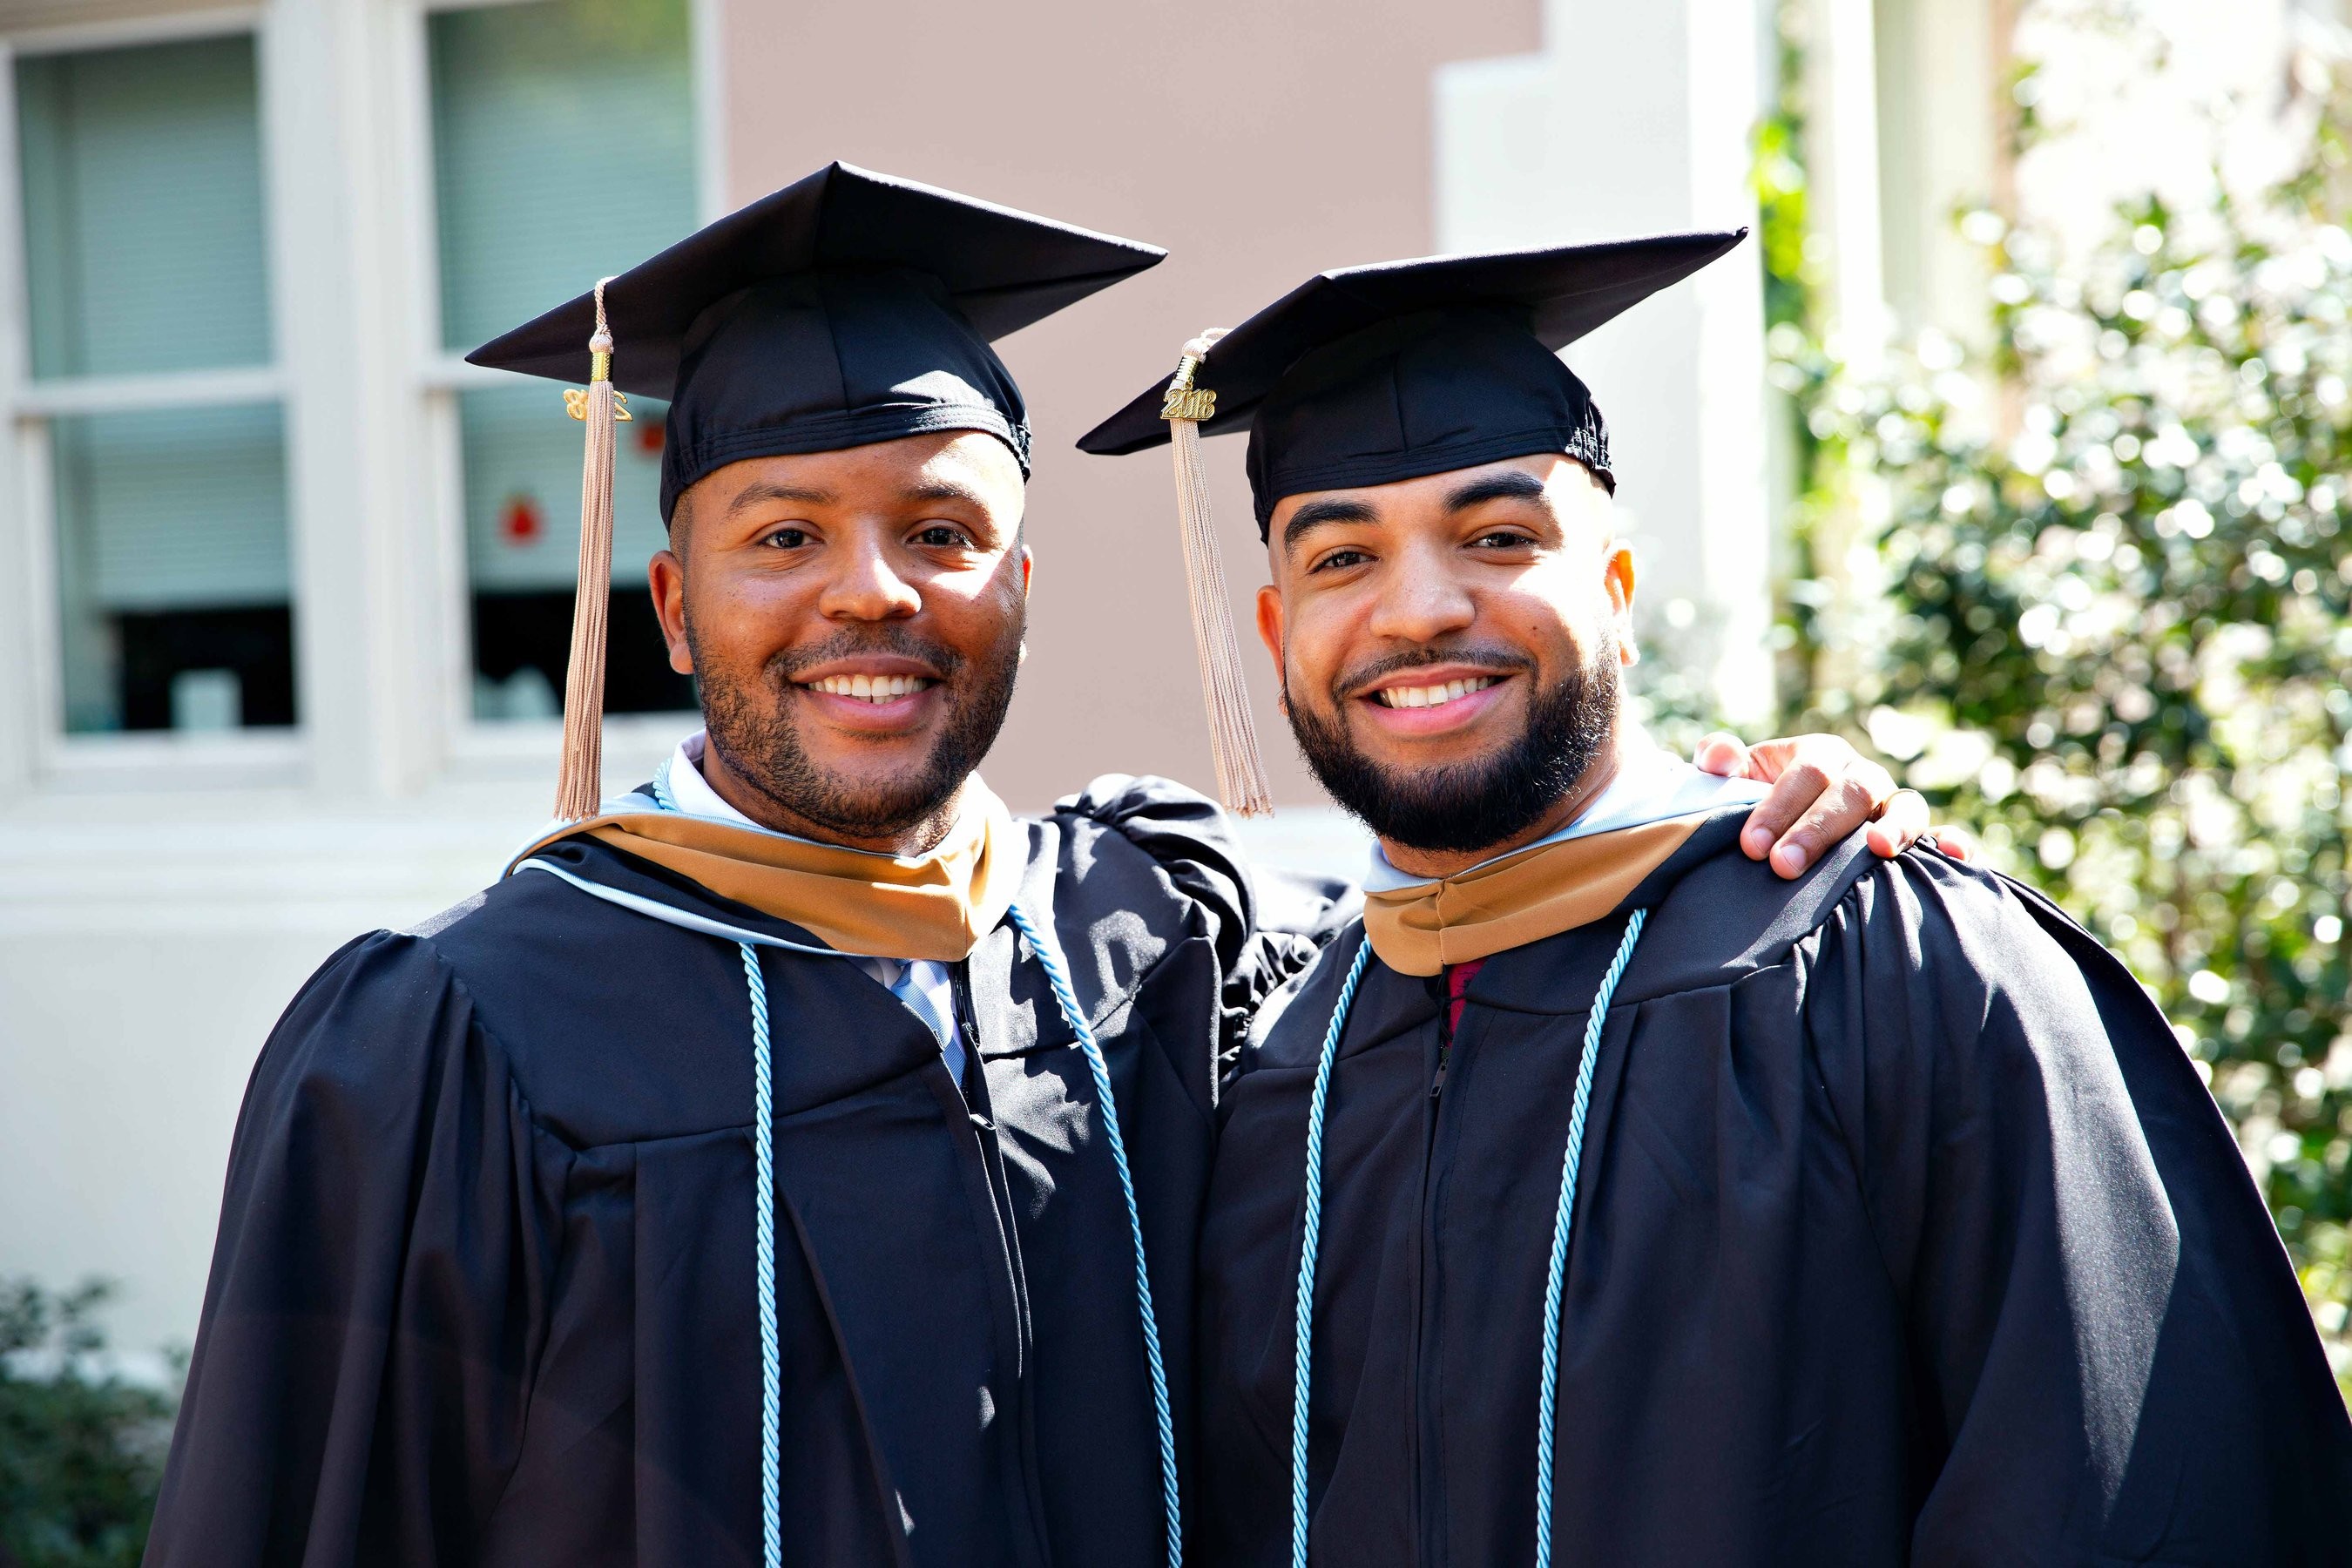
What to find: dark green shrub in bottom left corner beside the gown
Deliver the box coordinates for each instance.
[0,1279,174,1568]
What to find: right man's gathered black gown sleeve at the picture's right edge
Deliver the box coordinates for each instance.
[1794,851,2352,1568]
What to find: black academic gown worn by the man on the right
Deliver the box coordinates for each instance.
[1200,814,2352,1568]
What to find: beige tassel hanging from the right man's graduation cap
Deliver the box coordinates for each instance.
[1159,327,1274,815]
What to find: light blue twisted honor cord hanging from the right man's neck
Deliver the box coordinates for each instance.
[1291,909,1649,1568]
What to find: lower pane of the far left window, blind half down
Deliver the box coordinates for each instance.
[50,404,294,731]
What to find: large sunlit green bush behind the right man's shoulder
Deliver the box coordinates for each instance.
[1767,15,2352,1389]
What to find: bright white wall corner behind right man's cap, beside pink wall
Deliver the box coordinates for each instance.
[1435,0,1771,720]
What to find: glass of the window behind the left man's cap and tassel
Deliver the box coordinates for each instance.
[428,0,696,720]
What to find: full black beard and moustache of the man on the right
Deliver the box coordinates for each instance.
[1284,635,1619,854]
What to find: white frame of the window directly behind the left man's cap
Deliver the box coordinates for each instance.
[400,0,727,781]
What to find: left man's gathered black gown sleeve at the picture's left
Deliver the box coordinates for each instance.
[145,933,564,1568]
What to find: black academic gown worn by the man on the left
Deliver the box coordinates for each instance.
[145,778,1313,1568]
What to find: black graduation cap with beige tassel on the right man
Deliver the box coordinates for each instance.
[1078,228,1747,814]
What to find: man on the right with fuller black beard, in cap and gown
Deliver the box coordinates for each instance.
[1085,233,2352,1568]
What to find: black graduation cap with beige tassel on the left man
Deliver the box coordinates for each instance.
[466,162,1166,821]
